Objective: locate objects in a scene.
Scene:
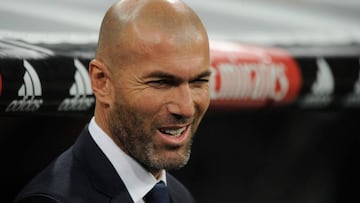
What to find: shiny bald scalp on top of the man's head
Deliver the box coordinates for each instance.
[96,0,208,68]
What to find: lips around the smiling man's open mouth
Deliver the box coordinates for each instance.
[157,124,191,145]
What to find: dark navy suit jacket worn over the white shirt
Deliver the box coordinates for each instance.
[14,126,195,203]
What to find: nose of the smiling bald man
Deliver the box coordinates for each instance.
[167,84,195,118]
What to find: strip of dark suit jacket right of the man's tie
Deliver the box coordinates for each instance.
[166,173,195,203]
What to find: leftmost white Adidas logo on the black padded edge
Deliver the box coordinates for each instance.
[5,60,43,112]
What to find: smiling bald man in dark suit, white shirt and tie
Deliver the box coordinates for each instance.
[15,0,210,203]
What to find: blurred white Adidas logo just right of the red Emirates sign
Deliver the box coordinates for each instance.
[300,58,335,107]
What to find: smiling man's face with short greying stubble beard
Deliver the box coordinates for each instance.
[110,36,210,169]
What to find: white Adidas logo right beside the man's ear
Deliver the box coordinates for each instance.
[58,59,95,111]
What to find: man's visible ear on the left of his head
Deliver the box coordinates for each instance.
[89,59,113,105]
